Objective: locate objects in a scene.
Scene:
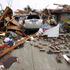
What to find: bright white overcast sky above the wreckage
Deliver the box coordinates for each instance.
[0,0,70,10]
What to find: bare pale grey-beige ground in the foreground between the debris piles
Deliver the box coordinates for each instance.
[8,36,70,70]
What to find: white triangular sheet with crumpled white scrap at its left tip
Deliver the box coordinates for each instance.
[36,24,60,37]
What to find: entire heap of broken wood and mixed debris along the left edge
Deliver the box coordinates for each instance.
[0,7,29,70]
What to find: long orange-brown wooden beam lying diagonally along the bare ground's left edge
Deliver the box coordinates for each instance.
[0,37,29,57]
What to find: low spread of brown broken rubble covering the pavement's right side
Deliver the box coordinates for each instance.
[31,34,70,64]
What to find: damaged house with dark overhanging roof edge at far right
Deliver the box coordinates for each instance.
[50,5,70,32]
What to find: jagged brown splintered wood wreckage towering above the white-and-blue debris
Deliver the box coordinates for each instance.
[0,7,22,34]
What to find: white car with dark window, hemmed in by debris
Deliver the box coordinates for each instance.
[24,14,42,29]
